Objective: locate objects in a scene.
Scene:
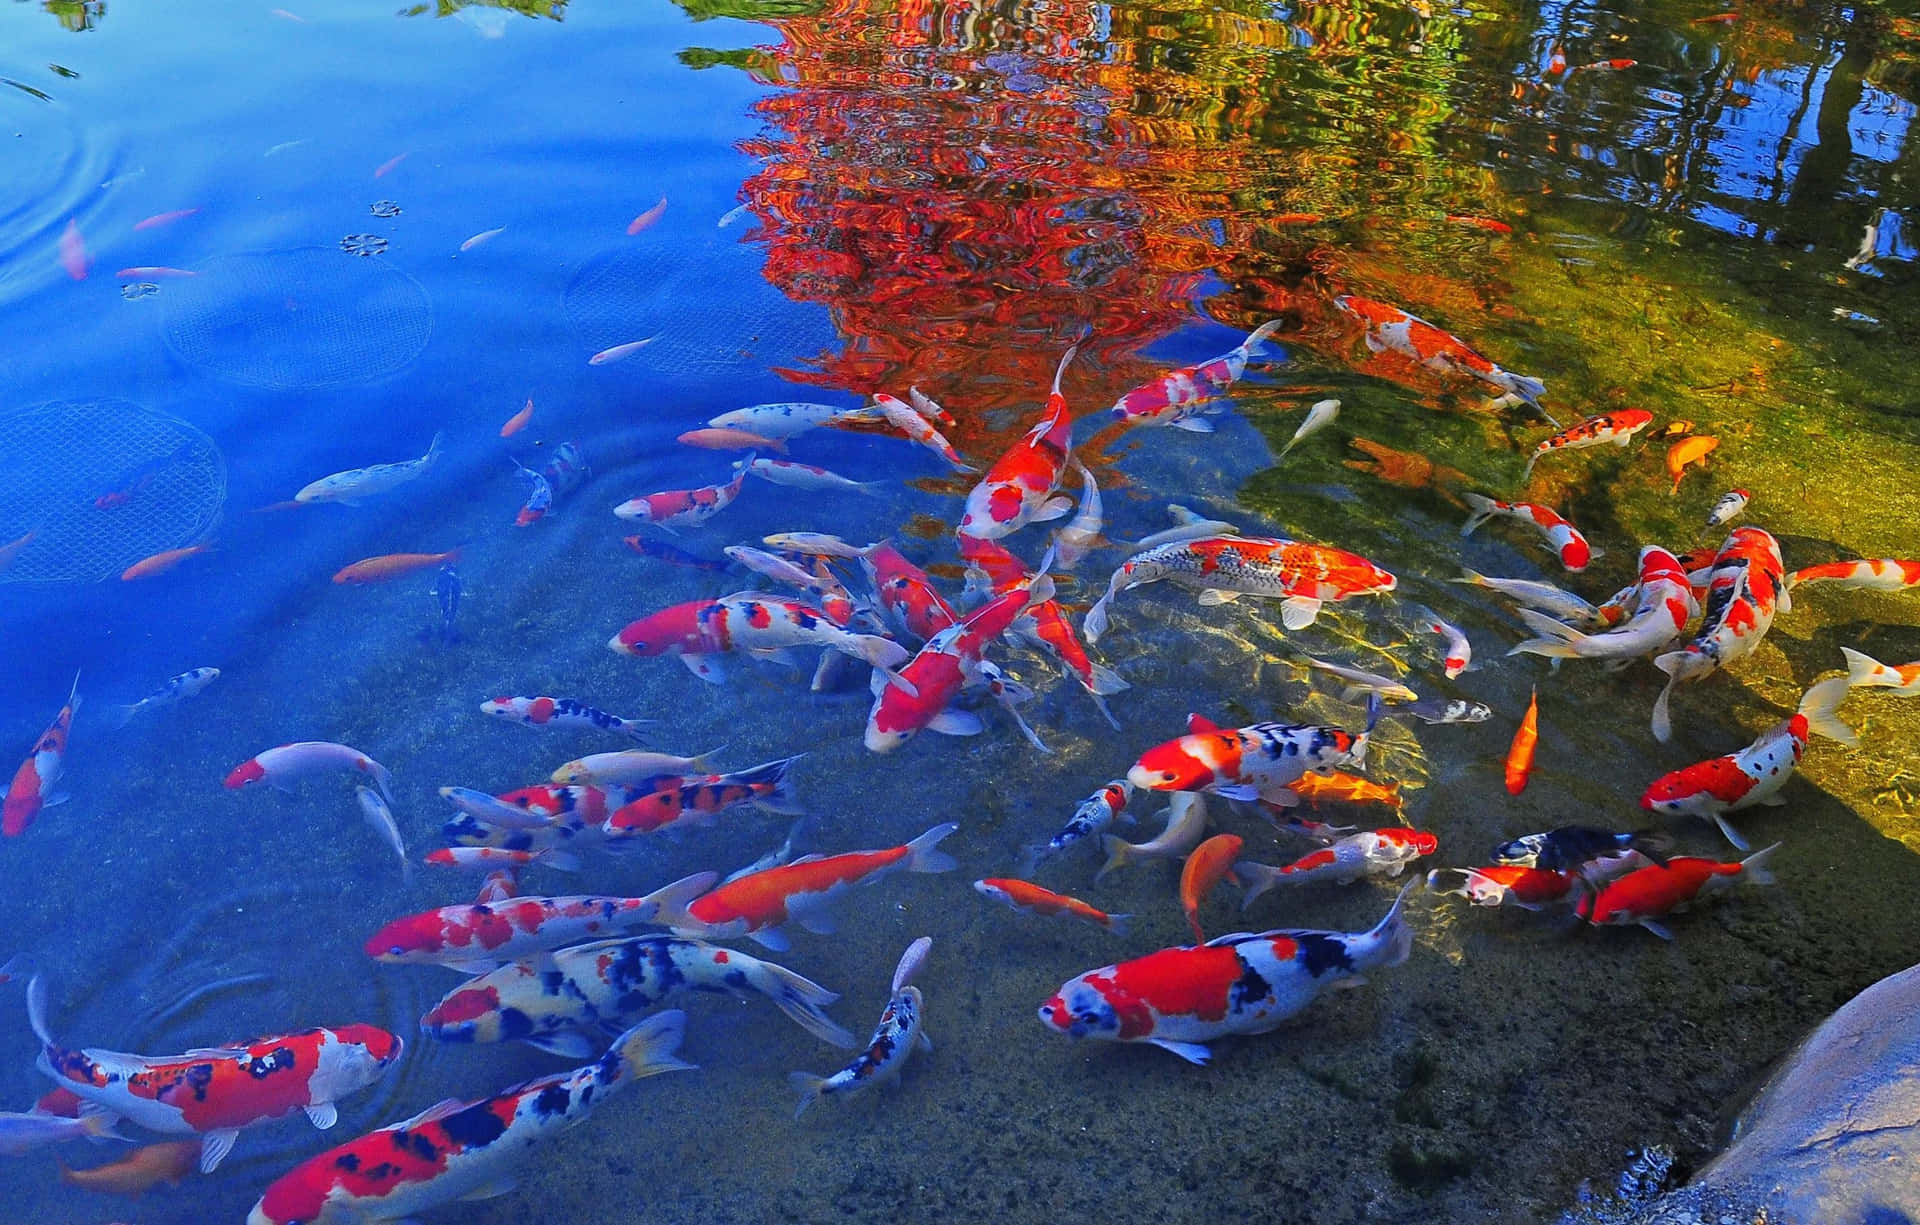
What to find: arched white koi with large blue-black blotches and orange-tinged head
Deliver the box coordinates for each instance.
[420,935,852,1060]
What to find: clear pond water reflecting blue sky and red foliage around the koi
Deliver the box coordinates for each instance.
[0,2,1920,1221]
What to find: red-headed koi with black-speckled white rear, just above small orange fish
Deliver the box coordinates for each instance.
[1127,697,1380,808]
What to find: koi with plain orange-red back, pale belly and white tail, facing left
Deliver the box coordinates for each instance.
[672,822,960,952]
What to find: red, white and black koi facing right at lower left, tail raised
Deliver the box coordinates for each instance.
[27,975,403,1173]
